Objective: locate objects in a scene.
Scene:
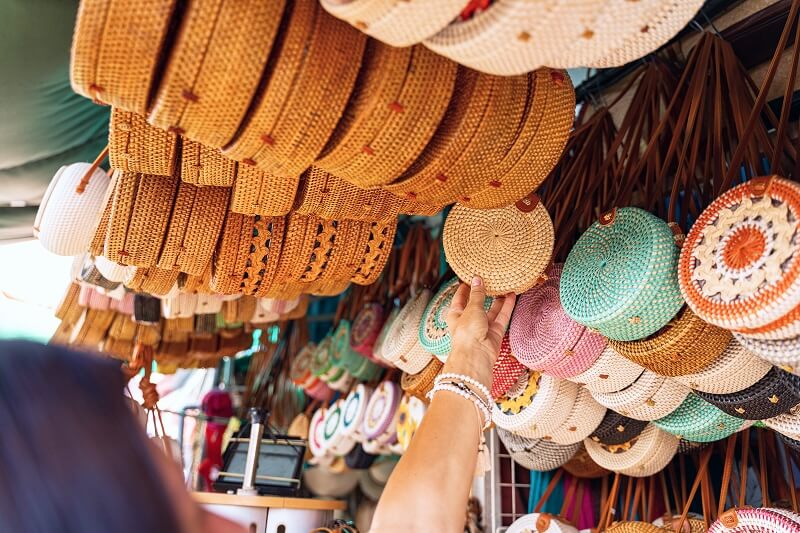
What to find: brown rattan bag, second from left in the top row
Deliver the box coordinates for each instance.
[149,0,285,148]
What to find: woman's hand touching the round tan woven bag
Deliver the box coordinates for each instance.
[444,277,516,388]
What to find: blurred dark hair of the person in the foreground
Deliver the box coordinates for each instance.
[0,341,181,533]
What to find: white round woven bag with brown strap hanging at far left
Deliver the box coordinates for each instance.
[33,163,109,255]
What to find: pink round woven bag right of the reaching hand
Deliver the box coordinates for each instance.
[509,264,606,379]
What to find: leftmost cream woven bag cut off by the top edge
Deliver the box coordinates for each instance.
[322,0,468,46]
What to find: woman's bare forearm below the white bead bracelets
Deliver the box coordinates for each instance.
[372,391,481,533]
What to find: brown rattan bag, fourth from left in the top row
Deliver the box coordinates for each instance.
[314,41,456,188]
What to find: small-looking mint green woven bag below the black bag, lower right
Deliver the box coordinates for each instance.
[653,393,746,442]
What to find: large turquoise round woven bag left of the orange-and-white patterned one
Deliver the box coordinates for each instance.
[560,207,684,341]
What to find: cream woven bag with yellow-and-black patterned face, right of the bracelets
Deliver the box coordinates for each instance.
[492,371,578,438]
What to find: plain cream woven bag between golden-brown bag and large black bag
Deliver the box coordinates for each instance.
[675,339,772,394]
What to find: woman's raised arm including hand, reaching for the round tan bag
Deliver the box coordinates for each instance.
[372,278,514,533]
